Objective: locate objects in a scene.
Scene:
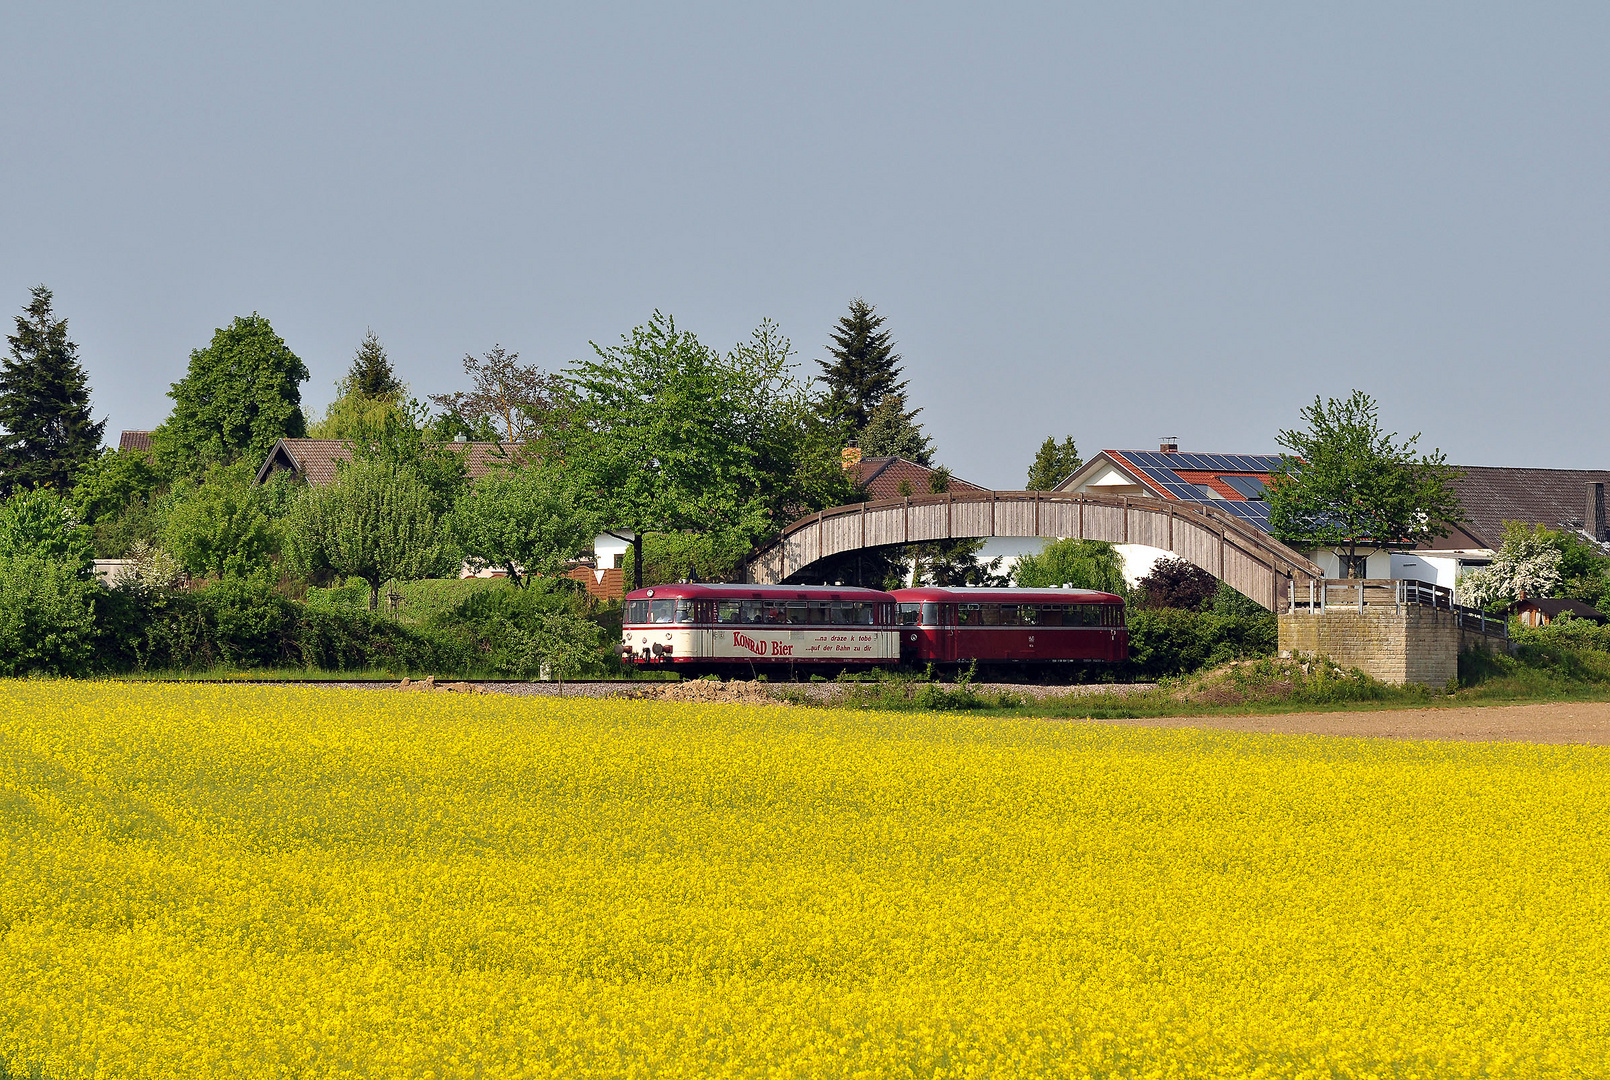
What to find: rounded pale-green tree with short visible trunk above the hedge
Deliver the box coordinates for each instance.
[285,459,454,610]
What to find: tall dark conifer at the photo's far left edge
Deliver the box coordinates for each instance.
[0,285,106,496]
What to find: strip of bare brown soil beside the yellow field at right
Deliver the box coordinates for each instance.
[1096,702,1610,747]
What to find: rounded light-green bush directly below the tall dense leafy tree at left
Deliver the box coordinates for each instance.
[158,462,280,578]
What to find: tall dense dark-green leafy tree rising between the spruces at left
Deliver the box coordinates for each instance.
[151,312,308,476]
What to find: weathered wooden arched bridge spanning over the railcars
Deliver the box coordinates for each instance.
[745,491,1325,612]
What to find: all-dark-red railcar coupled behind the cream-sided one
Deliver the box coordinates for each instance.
[894,587,1129,665]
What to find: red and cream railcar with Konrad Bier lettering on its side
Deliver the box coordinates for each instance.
[620,584,900,671]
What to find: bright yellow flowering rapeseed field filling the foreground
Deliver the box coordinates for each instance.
[0,682,1610,1080]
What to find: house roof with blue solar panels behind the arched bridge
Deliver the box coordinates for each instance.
[1056,441,1282,533]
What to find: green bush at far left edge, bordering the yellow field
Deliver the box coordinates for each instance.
[0,553,101,676]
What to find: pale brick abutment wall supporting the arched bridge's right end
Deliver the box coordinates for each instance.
[1278,604,1507,686]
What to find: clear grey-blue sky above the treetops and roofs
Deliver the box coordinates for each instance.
[0,3,1610,488]
